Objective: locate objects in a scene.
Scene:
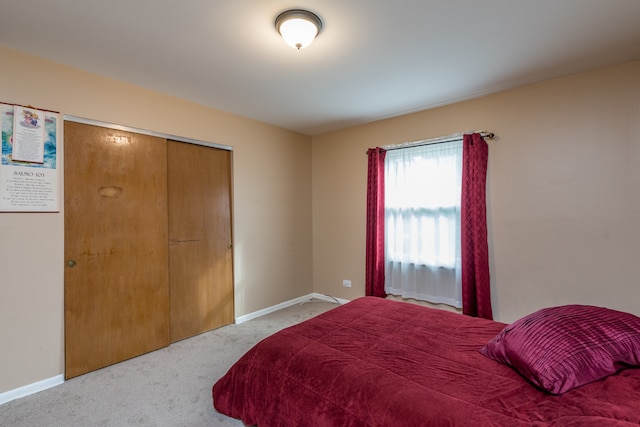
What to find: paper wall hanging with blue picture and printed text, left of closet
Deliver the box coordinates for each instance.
[0,103,60,212]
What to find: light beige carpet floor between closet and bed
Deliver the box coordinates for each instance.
[0,299,336,427]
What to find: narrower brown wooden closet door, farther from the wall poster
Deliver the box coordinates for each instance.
[168,141,233,342]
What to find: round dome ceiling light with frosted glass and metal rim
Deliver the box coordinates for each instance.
[275,9,322,50]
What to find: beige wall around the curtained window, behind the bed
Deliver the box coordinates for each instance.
[312,61,640,322]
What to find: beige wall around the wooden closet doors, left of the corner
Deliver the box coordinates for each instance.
[0,47,312,393]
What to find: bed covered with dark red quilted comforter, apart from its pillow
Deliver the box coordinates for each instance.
[212,297,640,427]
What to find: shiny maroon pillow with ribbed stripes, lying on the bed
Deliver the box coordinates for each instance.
[480,305,640,394]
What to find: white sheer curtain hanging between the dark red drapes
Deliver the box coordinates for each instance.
[385,141,462,308]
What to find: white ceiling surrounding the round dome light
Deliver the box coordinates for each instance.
[0,0,640,135]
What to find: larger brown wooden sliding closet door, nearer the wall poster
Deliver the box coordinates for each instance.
[64,122,170,378]
